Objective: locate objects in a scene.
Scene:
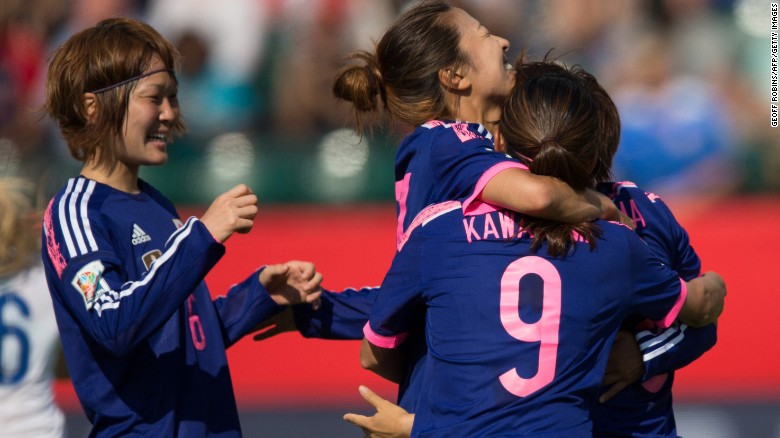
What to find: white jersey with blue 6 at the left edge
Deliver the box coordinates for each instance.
[0,265,65,438]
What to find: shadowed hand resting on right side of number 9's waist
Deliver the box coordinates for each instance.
[599,330,645,403]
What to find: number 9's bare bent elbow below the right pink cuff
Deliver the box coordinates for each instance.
[677,272,726,327]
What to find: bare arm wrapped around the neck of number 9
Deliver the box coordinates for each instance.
[480,168,621,223]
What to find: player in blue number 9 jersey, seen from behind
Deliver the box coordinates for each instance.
[361,55,725,437]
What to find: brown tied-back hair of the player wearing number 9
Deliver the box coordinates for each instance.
[499,56,604,256]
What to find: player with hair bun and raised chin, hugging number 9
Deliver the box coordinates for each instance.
[333,1,632,418]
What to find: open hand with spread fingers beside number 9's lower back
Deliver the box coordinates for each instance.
[344,385,414,438]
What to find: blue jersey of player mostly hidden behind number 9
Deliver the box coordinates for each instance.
[593,182,717,438]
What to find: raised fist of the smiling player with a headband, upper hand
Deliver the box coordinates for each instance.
[200,184,257,243]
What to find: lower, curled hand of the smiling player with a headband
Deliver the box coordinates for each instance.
[260,260,322,309]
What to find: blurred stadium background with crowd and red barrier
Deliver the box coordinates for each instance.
[0,0,780,438]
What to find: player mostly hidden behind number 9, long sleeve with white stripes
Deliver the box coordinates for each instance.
[572,62,717,438]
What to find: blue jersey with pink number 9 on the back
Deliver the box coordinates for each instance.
[365,202,686,438]
